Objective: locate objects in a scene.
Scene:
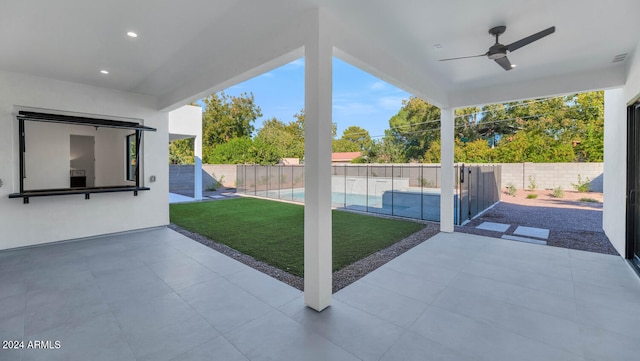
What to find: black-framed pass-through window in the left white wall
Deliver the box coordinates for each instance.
[9,111,155,204]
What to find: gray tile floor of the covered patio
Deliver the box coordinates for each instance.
[0,228,640,361]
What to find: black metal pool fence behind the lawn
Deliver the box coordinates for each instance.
[236,164,501,224]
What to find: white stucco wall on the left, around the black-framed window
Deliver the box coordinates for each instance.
[0,71,169,249]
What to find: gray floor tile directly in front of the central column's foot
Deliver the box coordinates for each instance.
[293,300,403,360]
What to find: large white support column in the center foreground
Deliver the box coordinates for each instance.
[304,10,333,311]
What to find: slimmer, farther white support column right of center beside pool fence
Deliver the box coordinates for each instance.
[440,108,456,232]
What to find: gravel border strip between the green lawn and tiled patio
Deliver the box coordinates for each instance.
[168,222,440,293]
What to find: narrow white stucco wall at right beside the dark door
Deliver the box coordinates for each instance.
[602,89,627,256]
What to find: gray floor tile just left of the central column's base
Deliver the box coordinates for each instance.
[227,269,302,308]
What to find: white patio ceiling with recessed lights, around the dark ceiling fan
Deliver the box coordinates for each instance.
[0,0,640,108]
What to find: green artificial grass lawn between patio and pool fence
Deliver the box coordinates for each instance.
[169,198,424,277]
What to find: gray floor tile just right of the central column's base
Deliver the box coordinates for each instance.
[334,282,427,327]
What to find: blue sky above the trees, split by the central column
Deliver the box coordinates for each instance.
[218,58,410,138]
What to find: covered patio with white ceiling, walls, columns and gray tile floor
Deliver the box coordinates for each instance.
[0,0,640,361]
